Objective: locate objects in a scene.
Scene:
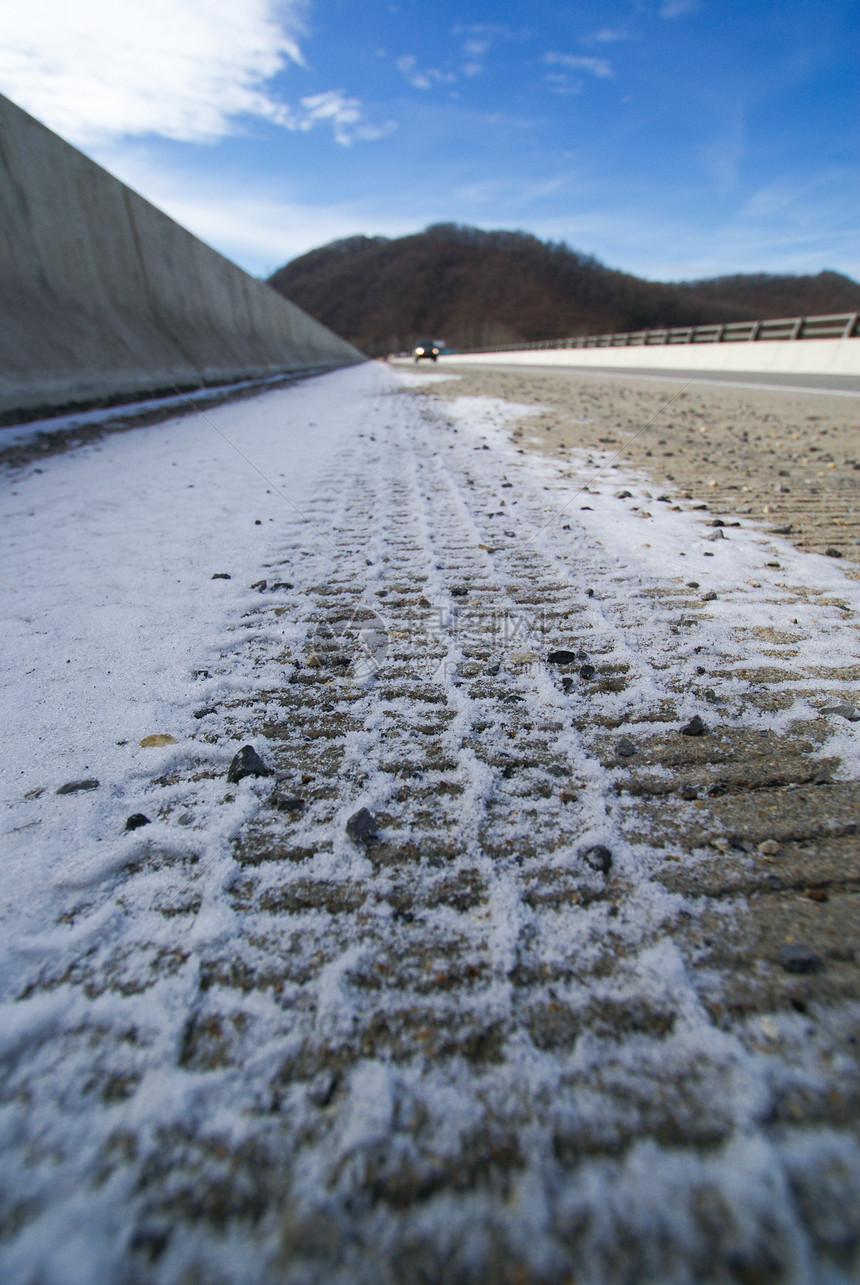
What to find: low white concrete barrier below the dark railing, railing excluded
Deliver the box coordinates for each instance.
[438,339,860,375]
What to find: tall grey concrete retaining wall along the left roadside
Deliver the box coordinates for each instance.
[0,95,365,416]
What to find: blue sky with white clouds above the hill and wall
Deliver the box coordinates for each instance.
[0,0,860,280]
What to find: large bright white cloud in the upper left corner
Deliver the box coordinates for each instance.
[0,0,305,144]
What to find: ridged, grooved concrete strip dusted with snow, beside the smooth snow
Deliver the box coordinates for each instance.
[4,372,860,1282]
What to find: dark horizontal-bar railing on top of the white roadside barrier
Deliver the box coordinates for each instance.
[459,312,860,352]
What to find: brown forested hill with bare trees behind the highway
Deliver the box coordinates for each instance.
[270,224,860,356]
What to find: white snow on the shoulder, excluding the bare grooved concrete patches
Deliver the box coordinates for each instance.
[0,364,860,1285]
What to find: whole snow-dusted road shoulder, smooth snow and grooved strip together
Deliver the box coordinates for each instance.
[0,364,860,1285]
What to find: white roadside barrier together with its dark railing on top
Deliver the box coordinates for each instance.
[440,312,860,375]
